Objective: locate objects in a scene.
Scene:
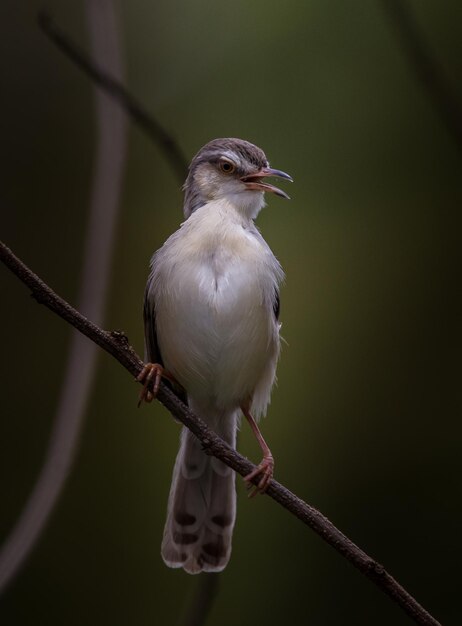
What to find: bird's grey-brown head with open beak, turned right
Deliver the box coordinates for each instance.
[184,139,292,219]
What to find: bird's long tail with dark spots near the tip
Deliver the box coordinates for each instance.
[161,403,237,574]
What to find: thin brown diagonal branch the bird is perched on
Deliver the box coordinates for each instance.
[0,242,440,626]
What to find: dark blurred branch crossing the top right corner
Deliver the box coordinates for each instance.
[381,0,462,150]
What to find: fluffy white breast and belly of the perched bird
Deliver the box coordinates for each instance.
[150,201,283,410]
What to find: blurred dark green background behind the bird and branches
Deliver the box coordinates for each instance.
[0,0,462,626]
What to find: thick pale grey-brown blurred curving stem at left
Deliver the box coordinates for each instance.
[0,0,127,593]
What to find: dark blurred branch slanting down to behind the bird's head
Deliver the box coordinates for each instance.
[38,13,188,184]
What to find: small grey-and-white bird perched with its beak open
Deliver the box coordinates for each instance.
[138,139,292,574]
